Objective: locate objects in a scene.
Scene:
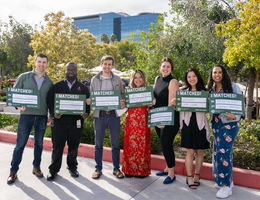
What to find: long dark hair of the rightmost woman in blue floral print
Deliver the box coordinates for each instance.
[208,64,233,93]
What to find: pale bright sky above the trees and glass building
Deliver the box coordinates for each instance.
[0,0,170,27]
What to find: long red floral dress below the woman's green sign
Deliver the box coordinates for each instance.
[122,106,151,176]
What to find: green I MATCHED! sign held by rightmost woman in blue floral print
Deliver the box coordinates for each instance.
[209,93,245,115]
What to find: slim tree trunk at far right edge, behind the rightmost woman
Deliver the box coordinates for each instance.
[246,67,255,120]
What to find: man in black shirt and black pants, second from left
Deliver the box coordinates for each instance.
[47,62,90,181]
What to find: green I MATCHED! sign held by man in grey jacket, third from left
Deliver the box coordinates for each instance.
[90,90,121,110]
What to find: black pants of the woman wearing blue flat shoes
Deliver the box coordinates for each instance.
[155,112,180,168]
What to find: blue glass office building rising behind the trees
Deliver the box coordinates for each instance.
[72,12,159,43]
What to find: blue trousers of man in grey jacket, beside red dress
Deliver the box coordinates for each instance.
[94,112,120,170]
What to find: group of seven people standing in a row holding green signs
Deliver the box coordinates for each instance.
[7,54,241,198]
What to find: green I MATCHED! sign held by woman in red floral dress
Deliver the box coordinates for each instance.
[125,86,153,108]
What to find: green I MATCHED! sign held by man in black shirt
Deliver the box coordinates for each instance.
[54,93,86,115]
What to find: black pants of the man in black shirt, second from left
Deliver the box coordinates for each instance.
[49,120,83,173]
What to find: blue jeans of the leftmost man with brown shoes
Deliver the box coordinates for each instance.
[10,115,47,172]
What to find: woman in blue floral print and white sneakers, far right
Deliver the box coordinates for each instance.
[208,65,242,198]
